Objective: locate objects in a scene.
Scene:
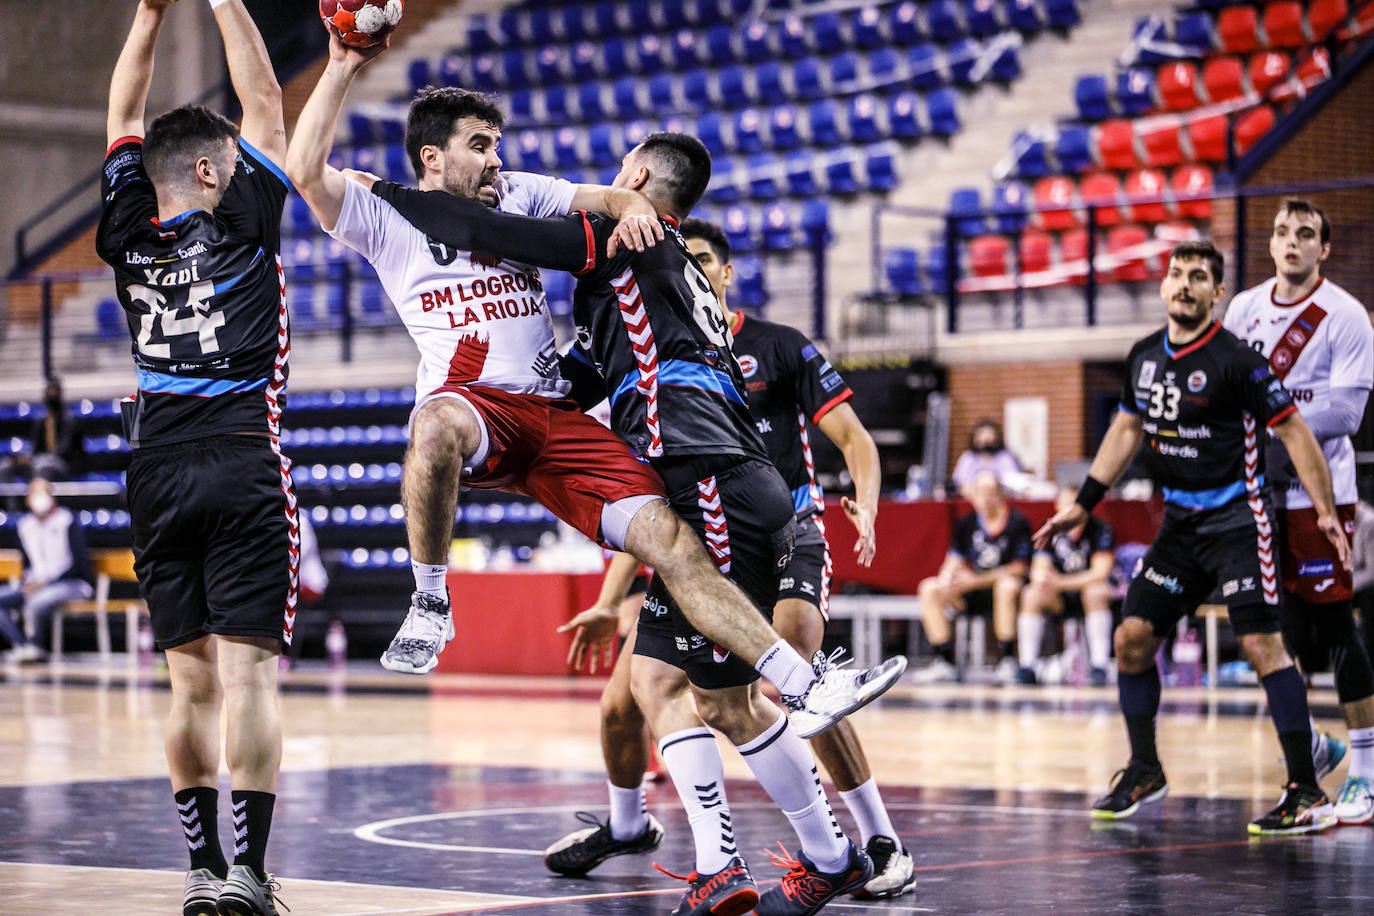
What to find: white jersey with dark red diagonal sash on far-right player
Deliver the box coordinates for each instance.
[1223,277,1374,509]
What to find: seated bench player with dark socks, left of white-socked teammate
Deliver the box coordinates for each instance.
[912,471,1031,684]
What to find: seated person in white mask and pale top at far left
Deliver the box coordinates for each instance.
[0,477,92,662]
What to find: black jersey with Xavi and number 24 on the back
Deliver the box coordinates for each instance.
[96,137,290,448]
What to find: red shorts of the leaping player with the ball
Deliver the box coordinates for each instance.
[428,387,668,545]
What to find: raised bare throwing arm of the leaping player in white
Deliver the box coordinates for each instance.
[286,34,386,232]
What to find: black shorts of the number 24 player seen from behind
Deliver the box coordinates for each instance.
[126,435,300,650]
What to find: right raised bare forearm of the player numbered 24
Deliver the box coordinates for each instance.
[212,0,286,163]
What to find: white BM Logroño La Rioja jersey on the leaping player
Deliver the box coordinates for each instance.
[330,172,576,401]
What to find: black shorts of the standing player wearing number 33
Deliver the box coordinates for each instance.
[1121,499,1279,636]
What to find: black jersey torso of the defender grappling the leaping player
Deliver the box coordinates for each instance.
[573,216,768,460]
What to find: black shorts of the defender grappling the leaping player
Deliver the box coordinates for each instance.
[635,456,797,689]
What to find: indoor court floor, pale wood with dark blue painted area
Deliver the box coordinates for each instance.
[0,663,1374,916]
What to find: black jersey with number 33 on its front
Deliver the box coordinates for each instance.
[1121,323,1297,509]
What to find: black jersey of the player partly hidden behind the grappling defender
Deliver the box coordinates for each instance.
[732,313,853,516]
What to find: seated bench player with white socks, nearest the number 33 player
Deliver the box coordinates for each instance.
[1017,486,1116,687]
